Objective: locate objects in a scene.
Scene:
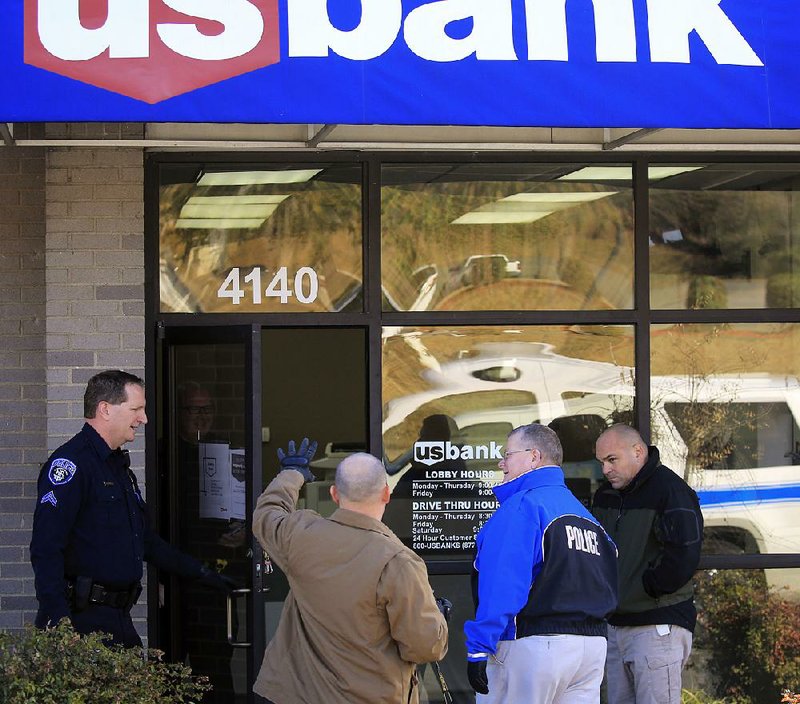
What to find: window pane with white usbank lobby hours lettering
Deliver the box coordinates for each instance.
[383,325,634,559]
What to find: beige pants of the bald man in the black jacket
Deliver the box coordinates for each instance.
[606,626,692,704]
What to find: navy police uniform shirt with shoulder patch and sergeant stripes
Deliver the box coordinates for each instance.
[31,423,201,623]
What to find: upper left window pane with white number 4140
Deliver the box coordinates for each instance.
[159,164,363,313]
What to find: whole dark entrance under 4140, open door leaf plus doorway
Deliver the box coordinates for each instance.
[155,326,368,704]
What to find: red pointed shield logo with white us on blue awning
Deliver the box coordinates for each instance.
[25,0,280,104]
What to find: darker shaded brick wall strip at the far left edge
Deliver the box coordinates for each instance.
[0,147,47,629]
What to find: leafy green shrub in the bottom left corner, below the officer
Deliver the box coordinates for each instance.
[0,619,211,704]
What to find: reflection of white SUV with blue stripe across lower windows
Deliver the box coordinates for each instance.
[384,343,800,589]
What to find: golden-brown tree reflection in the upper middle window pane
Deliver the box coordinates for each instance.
[381,182,633,309]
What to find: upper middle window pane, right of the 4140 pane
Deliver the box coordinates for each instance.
[381,164,633,311]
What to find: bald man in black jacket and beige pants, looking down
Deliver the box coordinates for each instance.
[592,425,703,704]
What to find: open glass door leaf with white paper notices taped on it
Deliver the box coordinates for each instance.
[157,327,256,704]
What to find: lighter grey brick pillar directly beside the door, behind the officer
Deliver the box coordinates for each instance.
[46,148,146,636]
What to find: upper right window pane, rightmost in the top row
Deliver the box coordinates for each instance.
[650,164,800,309]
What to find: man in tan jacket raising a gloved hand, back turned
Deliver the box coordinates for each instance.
[253,440,447,704]
